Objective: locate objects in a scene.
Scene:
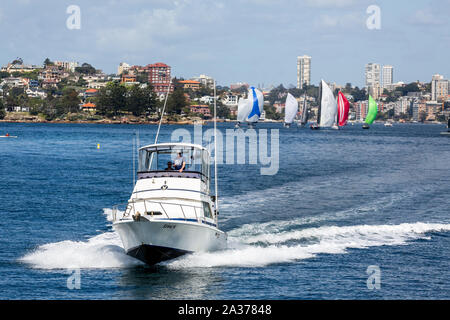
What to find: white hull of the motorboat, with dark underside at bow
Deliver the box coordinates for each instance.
[114,217,227,265]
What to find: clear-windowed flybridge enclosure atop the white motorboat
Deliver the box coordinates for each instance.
[139,145,210,179]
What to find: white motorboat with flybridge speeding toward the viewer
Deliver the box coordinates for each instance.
[113,143,227,265]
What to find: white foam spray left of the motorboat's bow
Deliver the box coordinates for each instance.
[19,232,142,269]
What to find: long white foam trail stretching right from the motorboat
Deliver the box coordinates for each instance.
[167,223,450,269]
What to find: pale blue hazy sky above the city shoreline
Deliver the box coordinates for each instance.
[0,0,450,87]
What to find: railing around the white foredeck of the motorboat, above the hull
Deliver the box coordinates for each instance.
[112,199,204,222]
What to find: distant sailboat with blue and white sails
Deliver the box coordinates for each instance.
[236,87,264,128]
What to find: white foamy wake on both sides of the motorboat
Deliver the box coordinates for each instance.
[19,209,450,269]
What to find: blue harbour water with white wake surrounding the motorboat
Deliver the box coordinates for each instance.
[0,123,450,299]
